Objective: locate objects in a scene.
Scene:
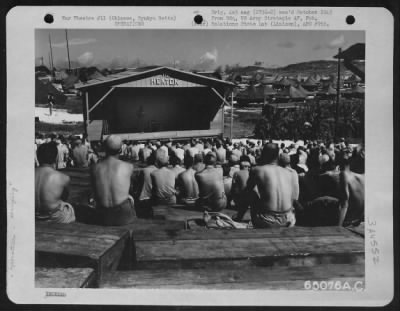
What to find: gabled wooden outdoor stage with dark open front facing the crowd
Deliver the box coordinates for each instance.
[75,67,234,141]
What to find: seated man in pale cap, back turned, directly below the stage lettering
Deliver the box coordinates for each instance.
[150,148,176,205]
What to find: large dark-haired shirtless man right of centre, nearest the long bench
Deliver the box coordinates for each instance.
[246,143,299,228]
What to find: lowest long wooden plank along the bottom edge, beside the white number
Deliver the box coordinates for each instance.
[100,264,365,290]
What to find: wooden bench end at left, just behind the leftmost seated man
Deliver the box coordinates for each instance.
[35,223,130,280]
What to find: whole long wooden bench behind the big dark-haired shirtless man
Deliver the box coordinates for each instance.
[133,227,364,269]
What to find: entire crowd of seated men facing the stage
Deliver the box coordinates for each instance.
[35,134,365,228]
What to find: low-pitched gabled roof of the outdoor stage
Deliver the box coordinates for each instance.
[75,67,235,90]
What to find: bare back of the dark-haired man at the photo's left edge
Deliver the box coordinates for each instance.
[35,166,70,213]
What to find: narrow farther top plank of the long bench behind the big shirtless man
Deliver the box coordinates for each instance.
[133,227,353,241]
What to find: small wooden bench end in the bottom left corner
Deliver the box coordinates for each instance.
[35,268,96,288]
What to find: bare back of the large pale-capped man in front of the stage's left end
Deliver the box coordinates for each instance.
[92,157,133,208]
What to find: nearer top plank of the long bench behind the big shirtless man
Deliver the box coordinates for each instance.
[135,230,364,269]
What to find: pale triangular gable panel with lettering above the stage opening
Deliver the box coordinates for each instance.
[116,74,206,88]
